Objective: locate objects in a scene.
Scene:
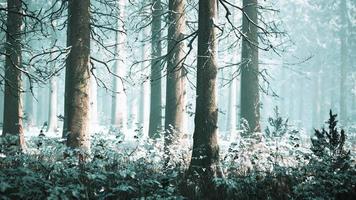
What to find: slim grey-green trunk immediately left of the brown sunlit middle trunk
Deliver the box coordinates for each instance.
[148,0,163,138]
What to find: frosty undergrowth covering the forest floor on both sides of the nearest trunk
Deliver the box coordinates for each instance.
[0,109,356,200]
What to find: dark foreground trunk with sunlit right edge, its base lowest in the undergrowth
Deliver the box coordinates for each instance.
[188,0,222,199]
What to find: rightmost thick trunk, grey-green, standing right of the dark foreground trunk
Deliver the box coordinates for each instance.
[241,0,261,132]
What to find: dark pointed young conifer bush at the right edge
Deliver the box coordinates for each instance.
[294,110,356,200]
